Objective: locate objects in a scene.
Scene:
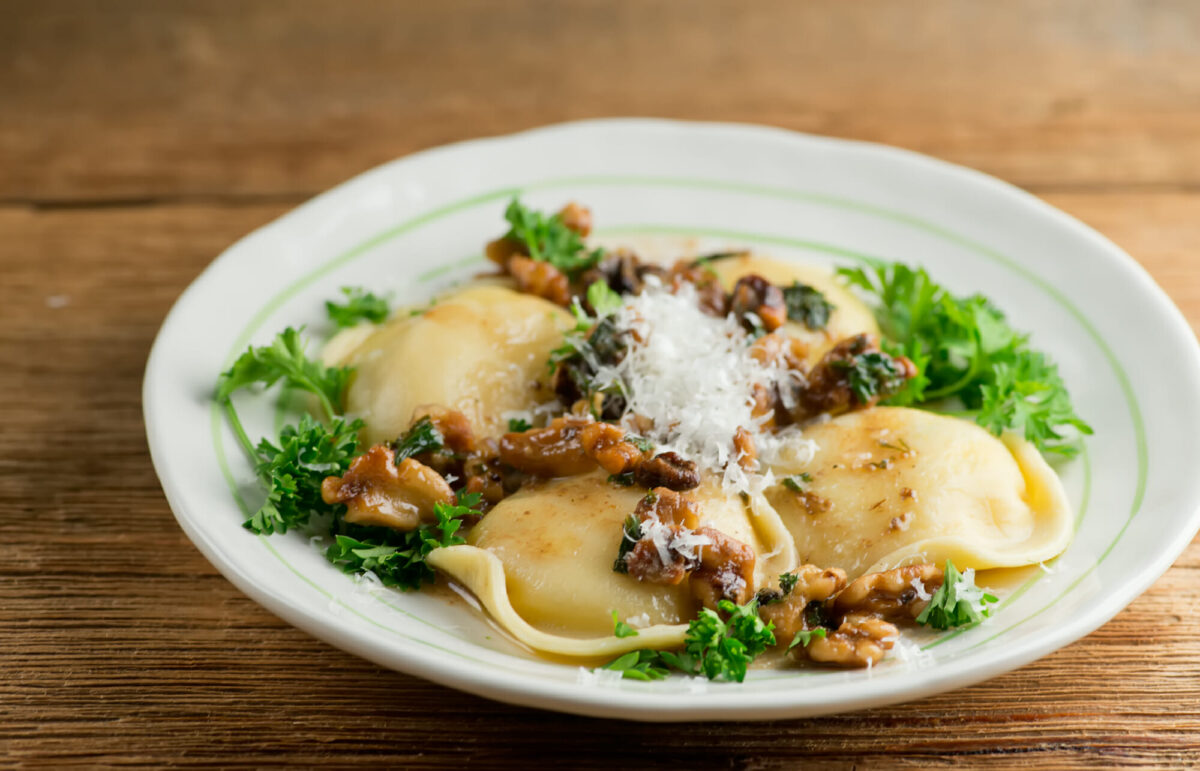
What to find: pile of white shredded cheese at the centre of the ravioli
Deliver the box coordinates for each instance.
[584,276,816,495]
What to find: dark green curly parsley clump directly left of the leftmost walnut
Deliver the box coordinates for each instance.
[244,416,362,534]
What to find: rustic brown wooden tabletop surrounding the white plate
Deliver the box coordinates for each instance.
[0,0,1200,769]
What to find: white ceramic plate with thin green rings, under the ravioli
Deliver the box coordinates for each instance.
[144,120,1200,721]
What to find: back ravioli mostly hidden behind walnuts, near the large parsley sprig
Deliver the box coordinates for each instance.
[710,255,880,365]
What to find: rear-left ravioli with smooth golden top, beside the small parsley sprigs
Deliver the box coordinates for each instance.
[333,285,571,443]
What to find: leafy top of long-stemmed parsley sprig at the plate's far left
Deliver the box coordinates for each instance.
[217,327,352,418]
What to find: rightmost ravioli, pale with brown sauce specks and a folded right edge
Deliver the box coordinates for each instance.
[767,407,1072,578]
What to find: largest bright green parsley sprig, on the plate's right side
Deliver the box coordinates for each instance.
[838,262,1092,456]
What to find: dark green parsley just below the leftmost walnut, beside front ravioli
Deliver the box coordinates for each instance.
[325,494,480,591]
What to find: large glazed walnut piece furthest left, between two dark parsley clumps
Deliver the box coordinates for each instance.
[320,444,455,530]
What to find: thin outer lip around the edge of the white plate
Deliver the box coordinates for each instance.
[143,118,1200,721]
